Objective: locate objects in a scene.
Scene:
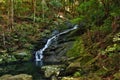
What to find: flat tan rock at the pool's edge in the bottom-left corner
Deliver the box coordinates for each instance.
[0,74,32,80]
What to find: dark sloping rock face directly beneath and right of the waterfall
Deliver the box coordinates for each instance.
[43,24,82,62]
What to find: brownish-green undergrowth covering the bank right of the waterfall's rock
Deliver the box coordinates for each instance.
[67,24,120,80]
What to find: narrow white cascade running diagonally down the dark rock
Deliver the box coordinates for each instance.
[35,25,78,61]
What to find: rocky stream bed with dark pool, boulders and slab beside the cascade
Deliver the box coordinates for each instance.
[0,23,81,80]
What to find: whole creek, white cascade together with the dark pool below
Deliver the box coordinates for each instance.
[0,25,78,80]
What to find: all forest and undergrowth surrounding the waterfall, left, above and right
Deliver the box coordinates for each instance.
[0,0,120,80]
